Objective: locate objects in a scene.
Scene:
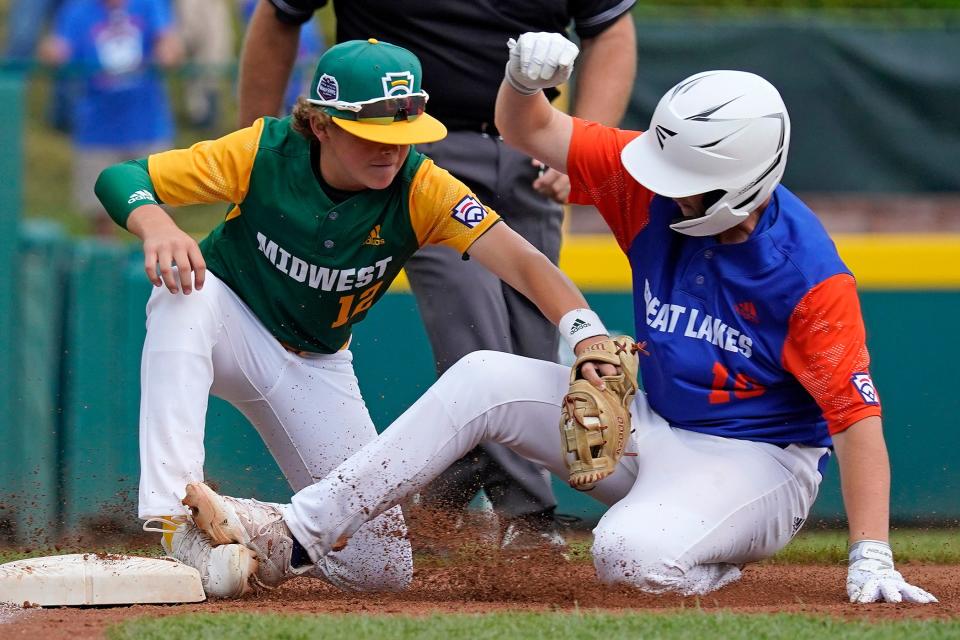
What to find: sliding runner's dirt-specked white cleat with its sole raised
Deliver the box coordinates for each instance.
[183,482,312,587]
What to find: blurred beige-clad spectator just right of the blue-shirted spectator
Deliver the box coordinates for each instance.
[175,0,234,130]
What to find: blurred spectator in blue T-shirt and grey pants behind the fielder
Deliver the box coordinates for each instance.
[40,0,181,236]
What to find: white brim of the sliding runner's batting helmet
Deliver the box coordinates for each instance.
[620,131,716,198]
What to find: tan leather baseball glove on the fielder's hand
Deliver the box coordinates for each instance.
[560,336,640,491]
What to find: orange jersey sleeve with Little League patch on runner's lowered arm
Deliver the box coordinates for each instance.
[783,274,880,434]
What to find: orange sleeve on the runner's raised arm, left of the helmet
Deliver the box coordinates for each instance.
[567,118,653,252]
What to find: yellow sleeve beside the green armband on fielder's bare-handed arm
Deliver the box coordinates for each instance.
[147,118,263,206]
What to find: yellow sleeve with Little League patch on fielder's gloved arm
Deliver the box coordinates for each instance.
[410,158,500,253]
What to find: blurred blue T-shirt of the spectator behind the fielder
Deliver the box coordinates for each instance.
[54,0,173,148]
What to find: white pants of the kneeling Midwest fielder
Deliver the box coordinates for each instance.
[139,271,413,590]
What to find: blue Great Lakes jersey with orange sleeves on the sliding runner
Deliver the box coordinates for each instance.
[568,121,879,446]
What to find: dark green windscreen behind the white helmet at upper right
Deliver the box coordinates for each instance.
[624,16,960,193]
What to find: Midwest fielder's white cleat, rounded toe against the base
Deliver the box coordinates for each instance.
[144,517,257,598]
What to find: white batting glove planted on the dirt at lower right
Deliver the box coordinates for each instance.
[847,540,939,604]
